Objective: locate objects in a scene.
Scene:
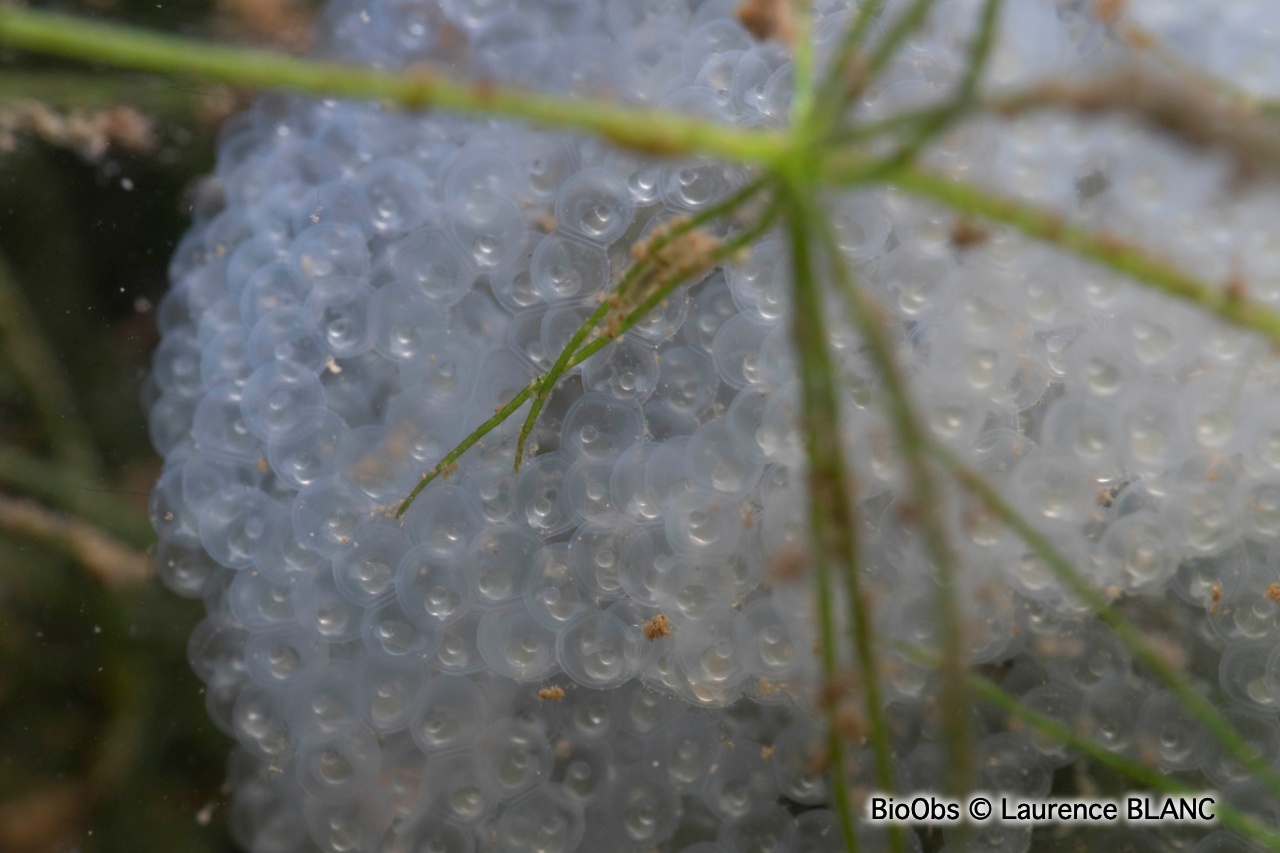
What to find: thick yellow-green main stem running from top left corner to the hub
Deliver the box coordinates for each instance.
[0,6,787,164]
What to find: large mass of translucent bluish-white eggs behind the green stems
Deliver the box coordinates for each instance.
[148,0,1280,853]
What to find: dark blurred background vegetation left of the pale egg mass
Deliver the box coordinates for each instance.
[0,0,316,853]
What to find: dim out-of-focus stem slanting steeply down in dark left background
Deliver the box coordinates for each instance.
[0,257,99,476]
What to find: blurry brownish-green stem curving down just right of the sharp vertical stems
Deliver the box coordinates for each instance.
[820,201,974,795]
